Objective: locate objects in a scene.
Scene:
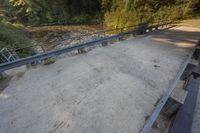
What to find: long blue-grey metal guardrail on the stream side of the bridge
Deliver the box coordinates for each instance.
[0,22,171,73]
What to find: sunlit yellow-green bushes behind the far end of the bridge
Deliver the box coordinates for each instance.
[102,0,199,28]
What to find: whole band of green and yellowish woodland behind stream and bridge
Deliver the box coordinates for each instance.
[0,0,200,55]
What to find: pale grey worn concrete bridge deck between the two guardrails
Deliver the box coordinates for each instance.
[0,20,200,133]
